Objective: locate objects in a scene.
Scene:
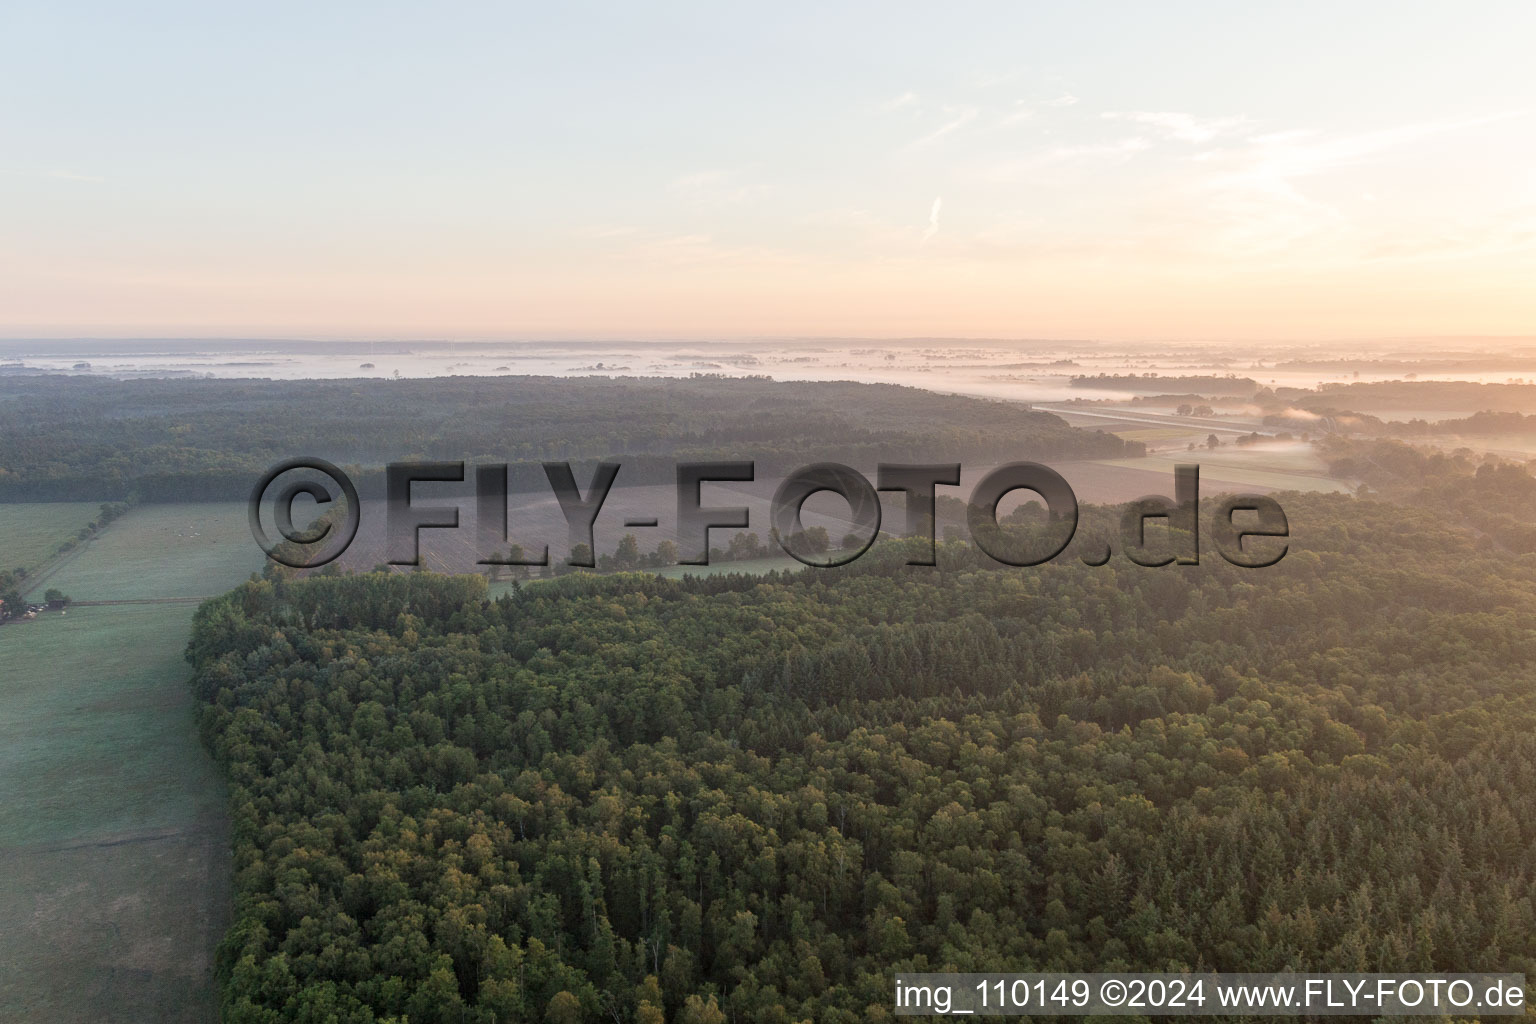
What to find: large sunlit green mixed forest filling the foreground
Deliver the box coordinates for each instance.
[187,494,1536,1024]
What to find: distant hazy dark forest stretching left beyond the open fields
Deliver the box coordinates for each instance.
[0,376,1143,500]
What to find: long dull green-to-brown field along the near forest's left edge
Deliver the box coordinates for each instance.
[0,604,229,1024]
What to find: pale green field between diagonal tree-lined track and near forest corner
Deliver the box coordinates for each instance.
[48,502,264,601]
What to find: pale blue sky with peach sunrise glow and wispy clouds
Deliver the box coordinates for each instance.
[0,0,1536,342]
